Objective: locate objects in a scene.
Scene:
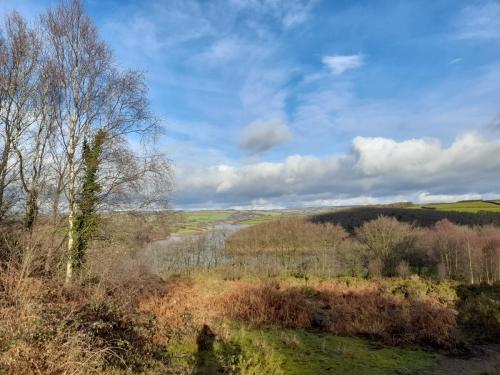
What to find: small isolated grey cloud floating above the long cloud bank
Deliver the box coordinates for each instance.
[240,120,292,154]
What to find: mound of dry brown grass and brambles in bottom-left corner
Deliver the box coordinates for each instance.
[0,271,168,374]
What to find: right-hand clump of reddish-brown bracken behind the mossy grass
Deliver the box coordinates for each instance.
[321,290,456,348]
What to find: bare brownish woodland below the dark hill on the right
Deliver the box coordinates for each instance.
[225,216,500,284]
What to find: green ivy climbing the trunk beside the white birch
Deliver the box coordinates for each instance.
[73,130,106,269]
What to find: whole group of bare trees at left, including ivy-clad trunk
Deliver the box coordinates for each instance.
[0,0,171,282]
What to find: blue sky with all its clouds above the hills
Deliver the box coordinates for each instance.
[0,0,500,209]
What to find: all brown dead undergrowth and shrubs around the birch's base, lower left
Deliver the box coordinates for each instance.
[0,216,167,374]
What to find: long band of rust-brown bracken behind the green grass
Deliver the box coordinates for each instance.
[221,282,457,349]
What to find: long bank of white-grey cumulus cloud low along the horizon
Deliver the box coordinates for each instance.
[176,133,500,207]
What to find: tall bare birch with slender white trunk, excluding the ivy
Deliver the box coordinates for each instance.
[43,0,170,281]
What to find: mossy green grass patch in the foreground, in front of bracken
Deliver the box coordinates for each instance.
[168,327,441,375]
